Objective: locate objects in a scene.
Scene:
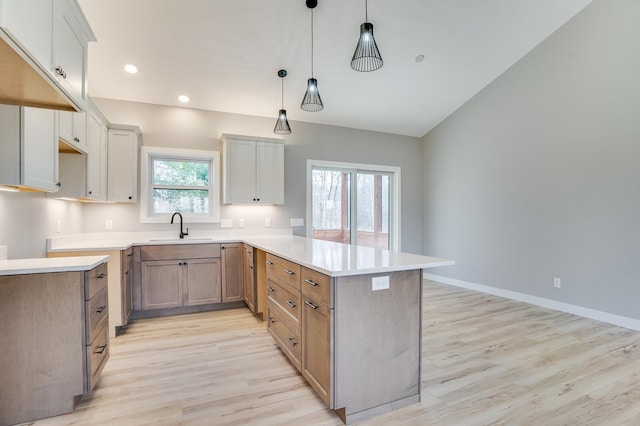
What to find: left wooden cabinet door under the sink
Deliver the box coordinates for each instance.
[142,260,183,310]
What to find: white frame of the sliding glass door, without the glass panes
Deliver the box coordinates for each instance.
[306,159,401,251]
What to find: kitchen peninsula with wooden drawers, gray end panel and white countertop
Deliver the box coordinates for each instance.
[50,234,453,423]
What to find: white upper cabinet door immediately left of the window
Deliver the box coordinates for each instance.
[107,126,140,203]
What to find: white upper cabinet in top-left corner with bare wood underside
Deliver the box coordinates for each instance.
[0,0,96,111]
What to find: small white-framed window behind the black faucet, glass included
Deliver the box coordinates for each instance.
[140,147,220,223]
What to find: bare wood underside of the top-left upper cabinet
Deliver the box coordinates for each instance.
[0,29,82,112]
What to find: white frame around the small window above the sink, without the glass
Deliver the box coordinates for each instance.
[140,146,220,223]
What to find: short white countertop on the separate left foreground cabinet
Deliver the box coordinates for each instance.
[0,256,109,275]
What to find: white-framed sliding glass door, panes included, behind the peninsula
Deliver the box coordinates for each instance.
[307,160,400,250]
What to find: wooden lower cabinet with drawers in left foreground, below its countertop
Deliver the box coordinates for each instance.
[0,263,109,425]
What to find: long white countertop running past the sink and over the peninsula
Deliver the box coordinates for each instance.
[47,230,455,277]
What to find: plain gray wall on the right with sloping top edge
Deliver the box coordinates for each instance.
[423,0,640,318]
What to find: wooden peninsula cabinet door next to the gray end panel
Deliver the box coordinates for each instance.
[302,297,333,408]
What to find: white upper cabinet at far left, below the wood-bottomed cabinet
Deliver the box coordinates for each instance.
[0,105,59,192]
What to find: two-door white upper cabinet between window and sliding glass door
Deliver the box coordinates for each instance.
[222,135,284,204]
